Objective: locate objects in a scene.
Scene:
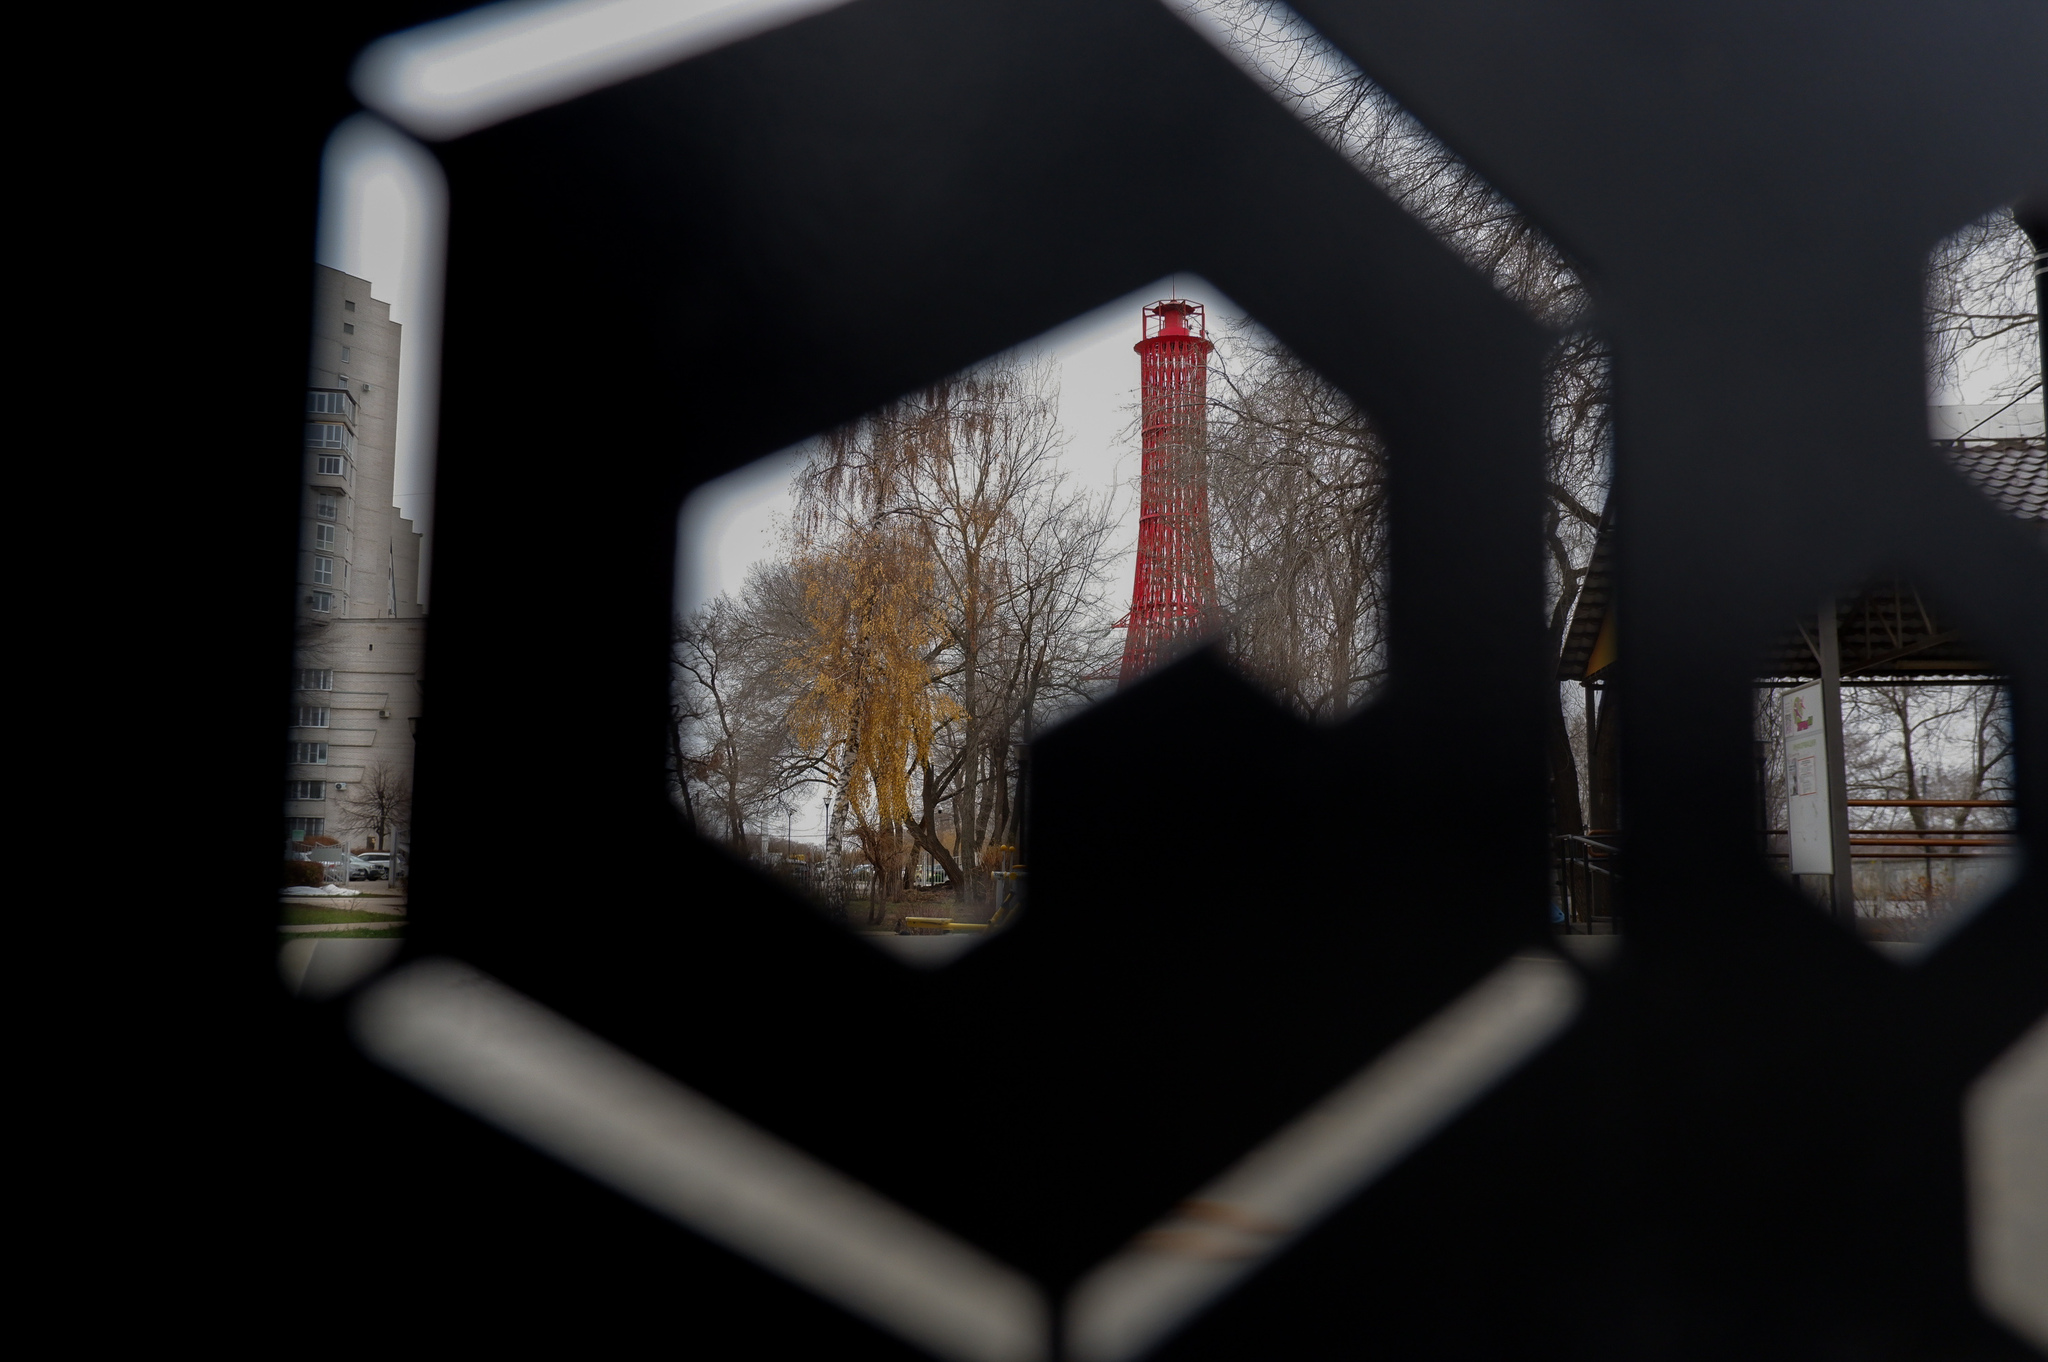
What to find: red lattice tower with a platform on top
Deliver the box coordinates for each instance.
[1116,299,1219,686]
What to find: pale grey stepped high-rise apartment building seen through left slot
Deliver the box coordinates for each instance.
[285,266,426,850]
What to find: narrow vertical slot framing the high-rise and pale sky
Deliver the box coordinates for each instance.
[279,115,446,997]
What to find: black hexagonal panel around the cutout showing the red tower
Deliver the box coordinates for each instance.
[416,4,1542,1280]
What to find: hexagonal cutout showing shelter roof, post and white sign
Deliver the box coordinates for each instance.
[1755,578,2019,948]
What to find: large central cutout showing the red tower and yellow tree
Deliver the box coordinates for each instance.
[668,276,1386,963]
